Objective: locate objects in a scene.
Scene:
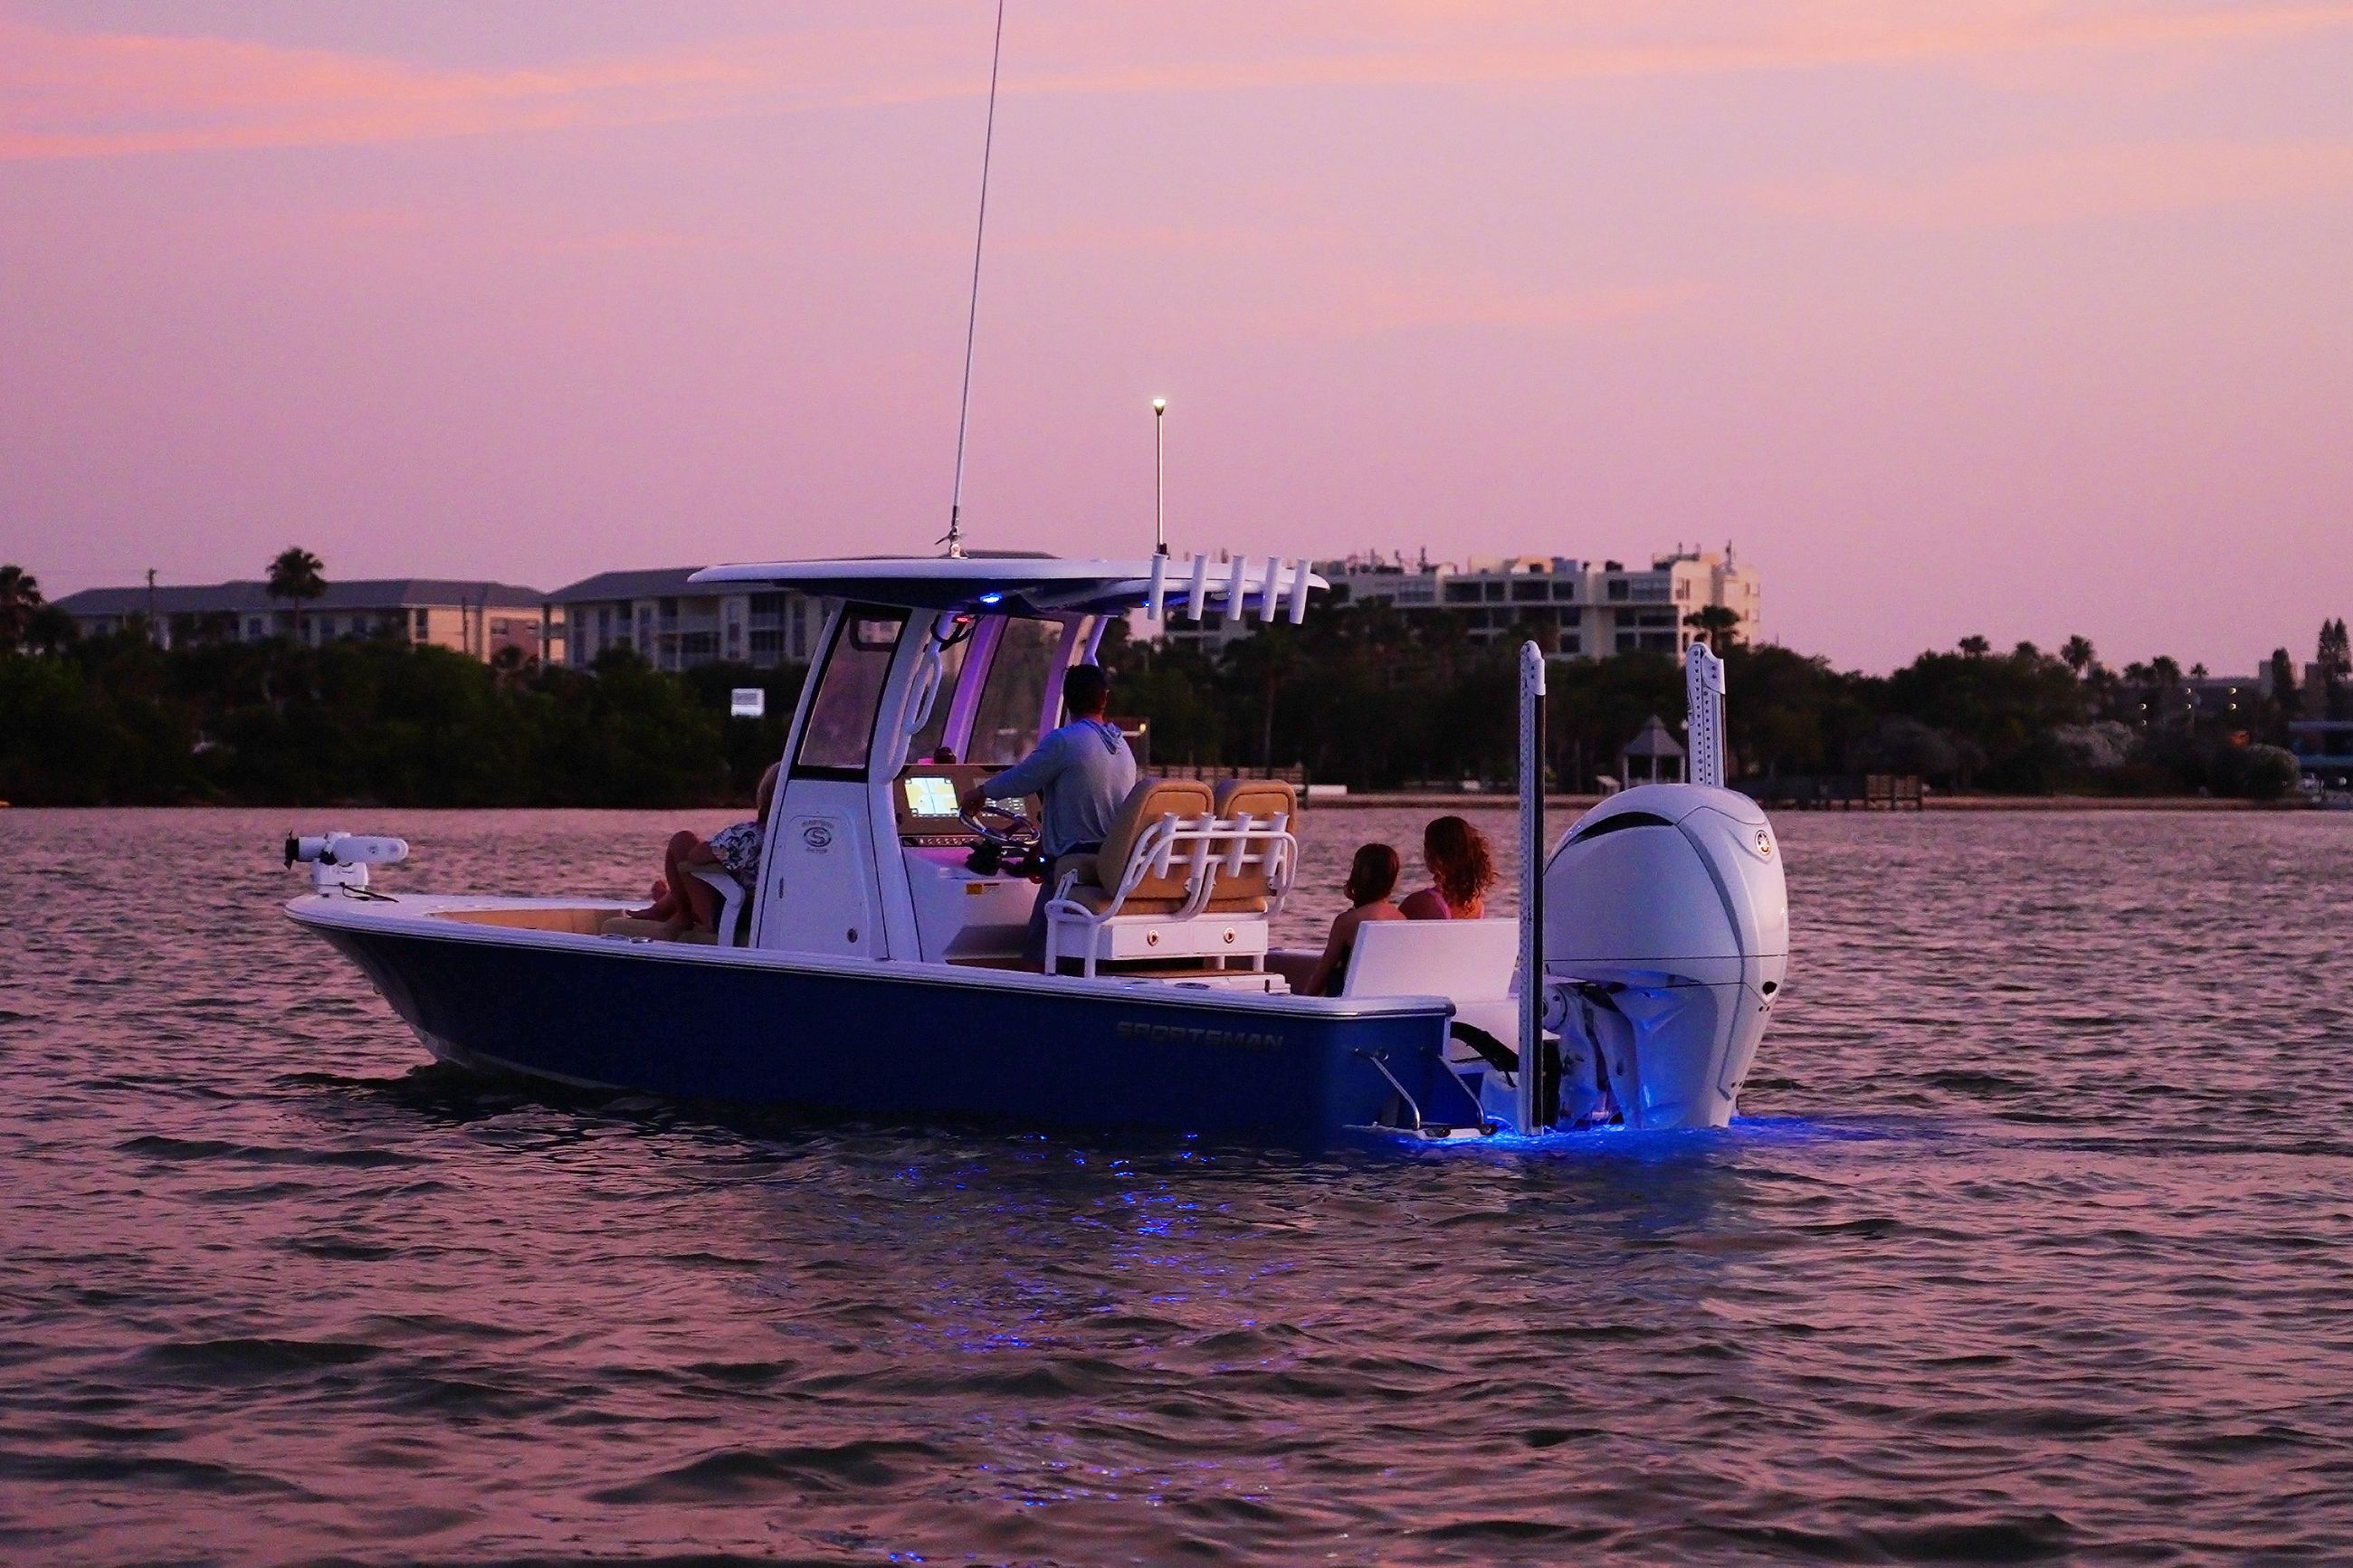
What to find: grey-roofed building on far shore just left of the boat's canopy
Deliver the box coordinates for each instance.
[546,566,826,670]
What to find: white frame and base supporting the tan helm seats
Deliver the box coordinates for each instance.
[1044,811,1299,975]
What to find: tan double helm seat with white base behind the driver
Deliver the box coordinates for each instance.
[1044,778,1299,975]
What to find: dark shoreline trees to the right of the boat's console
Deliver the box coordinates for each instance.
[1106,602,2324,797]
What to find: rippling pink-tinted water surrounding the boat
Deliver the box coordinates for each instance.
[0,811,2353,1563]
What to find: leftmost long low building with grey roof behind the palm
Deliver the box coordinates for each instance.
[56,578,562,660]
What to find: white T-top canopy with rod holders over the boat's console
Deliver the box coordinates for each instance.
[690,555,1329,618]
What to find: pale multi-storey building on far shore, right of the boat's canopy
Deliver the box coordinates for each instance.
[1141,546,1762,658]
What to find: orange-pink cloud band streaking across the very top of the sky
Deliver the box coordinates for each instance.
[14,0,2353,160]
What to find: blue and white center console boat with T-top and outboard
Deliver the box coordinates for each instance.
[287,555,1788,1147]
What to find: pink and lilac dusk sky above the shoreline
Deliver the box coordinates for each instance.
[0,0,2353,670]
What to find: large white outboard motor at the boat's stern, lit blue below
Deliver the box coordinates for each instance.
[1544,783,1788,1128]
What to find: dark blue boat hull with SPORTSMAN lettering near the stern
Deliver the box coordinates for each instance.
[290,905,1471,1147]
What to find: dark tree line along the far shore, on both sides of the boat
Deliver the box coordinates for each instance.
[0,553,2353,806]
